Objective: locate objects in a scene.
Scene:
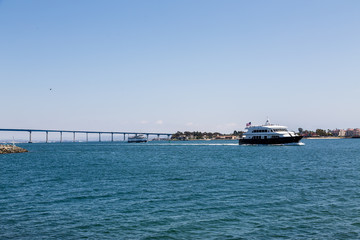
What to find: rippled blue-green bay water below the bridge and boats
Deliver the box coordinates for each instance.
[0,139,360,239]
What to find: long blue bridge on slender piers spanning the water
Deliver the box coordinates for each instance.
[0,128,173,143]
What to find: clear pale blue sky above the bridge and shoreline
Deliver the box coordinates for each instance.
[0,0,360,133]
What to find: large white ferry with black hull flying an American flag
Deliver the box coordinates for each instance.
[239,119,302,144]
